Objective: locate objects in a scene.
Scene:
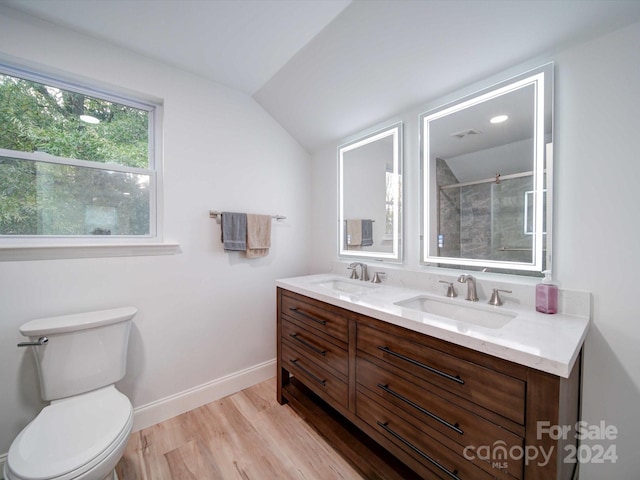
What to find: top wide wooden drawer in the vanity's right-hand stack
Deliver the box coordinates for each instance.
[357,324,525,425]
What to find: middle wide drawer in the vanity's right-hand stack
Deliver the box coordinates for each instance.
[356,358,524,478]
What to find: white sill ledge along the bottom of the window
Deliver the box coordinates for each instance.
[0,243,180,262]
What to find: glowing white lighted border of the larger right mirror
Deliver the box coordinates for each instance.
[419,62,554,272]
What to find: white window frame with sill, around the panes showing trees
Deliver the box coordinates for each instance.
[0,59,179,261]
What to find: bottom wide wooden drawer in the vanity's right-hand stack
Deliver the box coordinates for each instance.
[356,391,504,480]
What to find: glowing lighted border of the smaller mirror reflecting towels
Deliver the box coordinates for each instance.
[337,122,404,263]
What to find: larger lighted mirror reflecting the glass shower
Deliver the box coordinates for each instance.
[420,64,553,274]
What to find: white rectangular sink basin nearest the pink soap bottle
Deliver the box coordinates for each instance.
[395,295,516,328]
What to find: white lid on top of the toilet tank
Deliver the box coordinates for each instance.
[20,307,138,337]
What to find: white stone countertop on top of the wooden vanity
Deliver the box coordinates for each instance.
[276,274,589,378]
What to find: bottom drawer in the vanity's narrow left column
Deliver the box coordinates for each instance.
[282,342,349,408]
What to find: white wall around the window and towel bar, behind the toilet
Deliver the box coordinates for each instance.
[0,7,310,463]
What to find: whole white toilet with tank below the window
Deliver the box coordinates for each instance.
[4,307,137,480]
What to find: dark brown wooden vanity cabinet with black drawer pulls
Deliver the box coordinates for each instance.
[277,288,580,480]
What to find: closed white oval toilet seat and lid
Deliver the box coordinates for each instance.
[6,385,133,480]
